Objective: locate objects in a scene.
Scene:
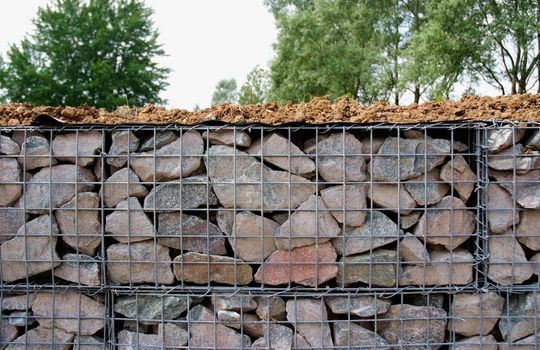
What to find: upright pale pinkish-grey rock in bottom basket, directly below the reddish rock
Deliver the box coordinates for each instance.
[286,298,334,348]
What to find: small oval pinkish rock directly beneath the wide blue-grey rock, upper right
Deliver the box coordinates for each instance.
[366,183,416,215]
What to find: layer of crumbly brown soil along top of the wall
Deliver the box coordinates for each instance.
[0,94,540,126]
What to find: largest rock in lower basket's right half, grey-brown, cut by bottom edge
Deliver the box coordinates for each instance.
[378,304,447,350]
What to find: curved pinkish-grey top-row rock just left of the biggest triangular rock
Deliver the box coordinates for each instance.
[131,131,204,182]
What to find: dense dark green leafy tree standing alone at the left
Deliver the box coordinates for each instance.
[0,0,170,109]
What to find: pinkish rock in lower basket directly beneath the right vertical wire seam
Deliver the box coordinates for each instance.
[448,292,504,337]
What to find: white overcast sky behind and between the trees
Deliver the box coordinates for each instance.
[0,0,277,109]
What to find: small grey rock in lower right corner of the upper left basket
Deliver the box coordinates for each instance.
[54,254,101,286]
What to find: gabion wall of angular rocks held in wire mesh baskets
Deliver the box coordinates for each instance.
[0,123,540,349]
